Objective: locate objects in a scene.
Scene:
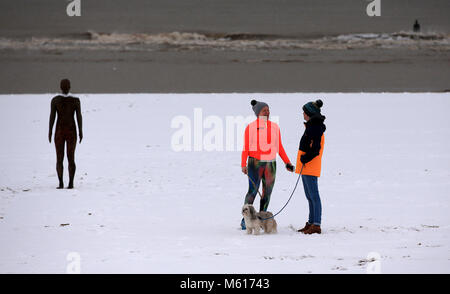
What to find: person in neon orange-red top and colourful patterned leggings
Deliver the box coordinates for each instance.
[241,100,294,230]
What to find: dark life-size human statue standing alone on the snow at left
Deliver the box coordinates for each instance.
[48,79,83,189]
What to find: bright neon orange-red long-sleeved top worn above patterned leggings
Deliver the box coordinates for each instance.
[241,118,290,167]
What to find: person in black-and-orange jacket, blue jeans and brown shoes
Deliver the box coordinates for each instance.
[295,99,326,234]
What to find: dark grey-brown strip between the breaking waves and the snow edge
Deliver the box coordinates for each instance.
[0,49,450,94]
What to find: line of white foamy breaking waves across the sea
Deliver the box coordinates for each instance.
[0,31,450,51]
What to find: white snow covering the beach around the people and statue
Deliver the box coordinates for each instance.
[0,93,450,274]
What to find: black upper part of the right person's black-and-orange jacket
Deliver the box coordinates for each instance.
[298,115,326,164]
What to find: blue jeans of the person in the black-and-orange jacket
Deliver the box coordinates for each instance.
[302,175,322,226]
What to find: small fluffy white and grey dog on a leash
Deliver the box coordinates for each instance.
[242,204,277,235]
